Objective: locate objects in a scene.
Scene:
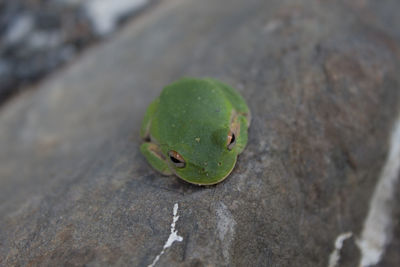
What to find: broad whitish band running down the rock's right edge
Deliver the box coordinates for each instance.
[357,120,400,267]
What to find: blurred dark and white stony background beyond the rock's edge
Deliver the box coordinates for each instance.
[0,0,157,105]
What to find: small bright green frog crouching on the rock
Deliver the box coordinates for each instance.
[140,77,251,186]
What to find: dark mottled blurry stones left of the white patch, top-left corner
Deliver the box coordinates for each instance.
[0,0,96,104]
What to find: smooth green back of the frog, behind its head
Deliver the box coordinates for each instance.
[152,78,233,147]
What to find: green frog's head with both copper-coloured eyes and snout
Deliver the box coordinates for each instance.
[163,124,247,185]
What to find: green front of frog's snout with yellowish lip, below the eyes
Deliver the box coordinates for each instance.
[175,156,237,185]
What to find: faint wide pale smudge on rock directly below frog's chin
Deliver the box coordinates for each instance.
[217,202,236,264]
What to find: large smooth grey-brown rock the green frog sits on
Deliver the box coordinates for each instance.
[0,0,400,266]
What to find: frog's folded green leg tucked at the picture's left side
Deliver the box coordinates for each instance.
[140,142,172,175]
